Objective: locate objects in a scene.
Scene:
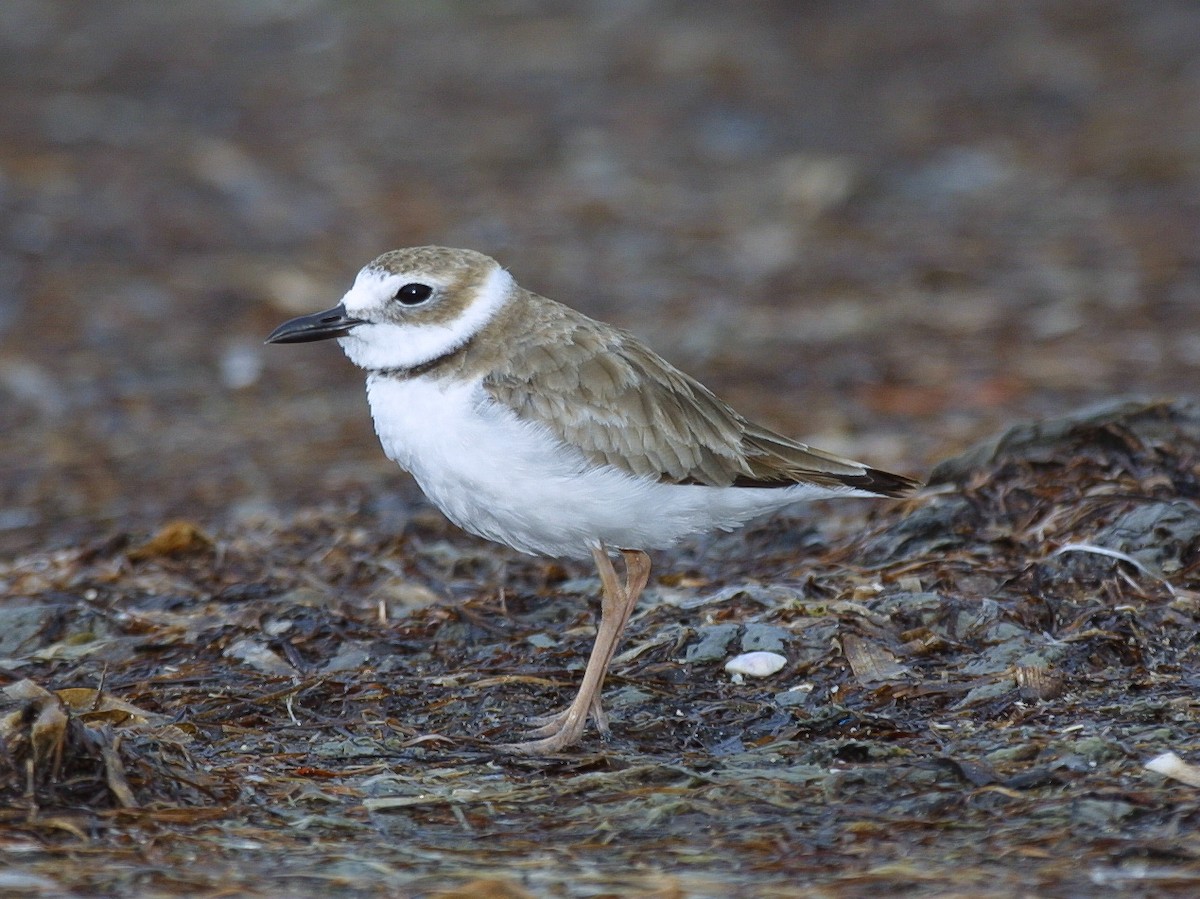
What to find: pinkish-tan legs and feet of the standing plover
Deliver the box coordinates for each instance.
[500,545,650,755]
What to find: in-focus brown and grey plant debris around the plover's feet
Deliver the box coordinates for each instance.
[0,402,1200,895]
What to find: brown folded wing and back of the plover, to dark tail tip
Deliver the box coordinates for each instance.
[484,294,916,496]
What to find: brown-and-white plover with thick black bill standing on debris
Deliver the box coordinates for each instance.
[268,247,917,754]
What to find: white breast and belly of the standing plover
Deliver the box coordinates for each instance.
[367,376,853,558]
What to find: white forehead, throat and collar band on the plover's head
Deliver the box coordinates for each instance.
[337,265,514,370]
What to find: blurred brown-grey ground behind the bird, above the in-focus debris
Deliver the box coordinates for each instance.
[0,0,1200,556]
